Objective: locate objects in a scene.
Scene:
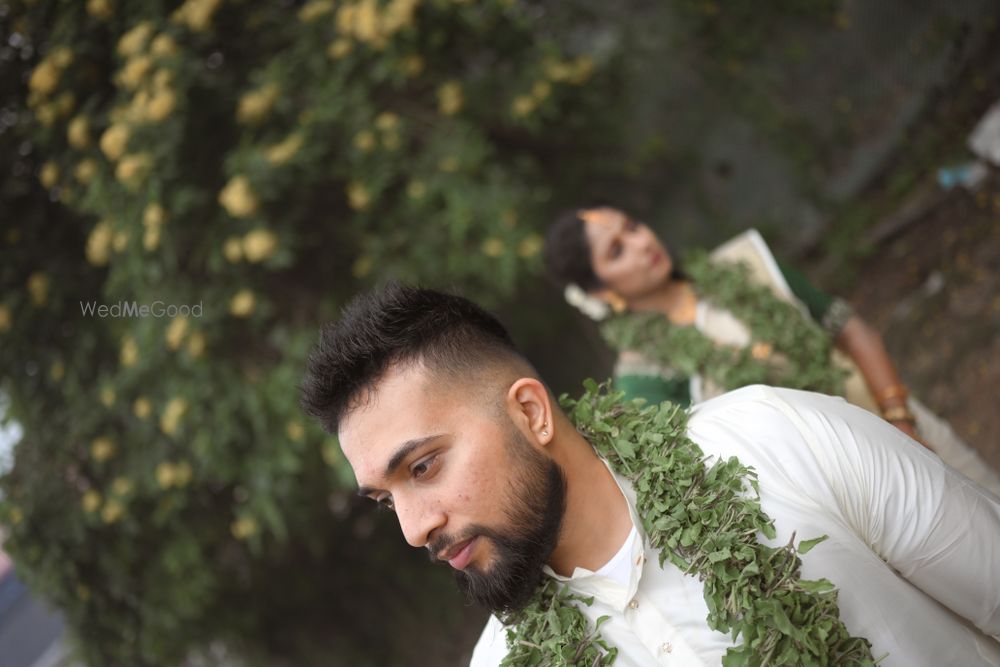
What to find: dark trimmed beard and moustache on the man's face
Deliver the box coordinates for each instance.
[429,424,566,615]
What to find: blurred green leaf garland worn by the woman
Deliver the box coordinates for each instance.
[601,253,846,395]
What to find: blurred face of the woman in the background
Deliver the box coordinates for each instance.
[580,208,673,301]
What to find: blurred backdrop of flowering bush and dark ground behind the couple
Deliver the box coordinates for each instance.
[0,0,1000,667]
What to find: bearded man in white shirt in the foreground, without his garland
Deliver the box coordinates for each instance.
[303,285,1000,666]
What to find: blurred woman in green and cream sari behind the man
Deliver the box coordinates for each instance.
[545,207,1000,493]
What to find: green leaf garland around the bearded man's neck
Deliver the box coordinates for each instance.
[501,380,876,667]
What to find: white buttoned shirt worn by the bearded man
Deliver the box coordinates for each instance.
[472,386,1000,667]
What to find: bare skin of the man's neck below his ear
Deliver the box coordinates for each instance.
[549,431,632,577]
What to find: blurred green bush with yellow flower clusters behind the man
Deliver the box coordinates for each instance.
[0,0,613,666]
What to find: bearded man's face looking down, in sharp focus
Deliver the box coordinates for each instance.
[340,364,565,612]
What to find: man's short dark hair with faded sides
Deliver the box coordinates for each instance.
[302,282,533,433]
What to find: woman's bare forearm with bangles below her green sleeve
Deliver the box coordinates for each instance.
[834,314,930,449]
